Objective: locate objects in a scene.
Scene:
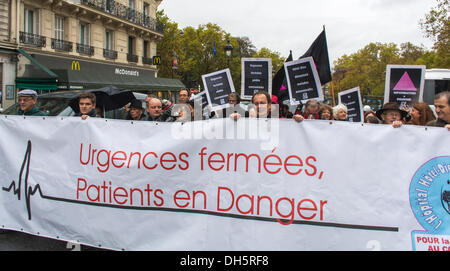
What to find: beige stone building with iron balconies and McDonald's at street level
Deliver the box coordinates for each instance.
[0,0,184,110]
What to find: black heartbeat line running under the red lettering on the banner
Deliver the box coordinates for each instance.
[2,140,398,232]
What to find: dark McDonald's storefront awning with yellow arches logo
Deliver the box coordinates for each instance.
[16,53,184,102]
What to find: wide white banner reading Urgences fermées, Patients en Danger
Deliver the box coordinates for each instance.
[0,116,450,250]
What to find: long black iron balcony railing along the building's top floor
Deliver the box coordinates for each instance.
[81,0,164,34]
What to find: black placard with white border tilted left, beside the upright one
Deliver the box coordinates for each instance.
[202,69,235,111]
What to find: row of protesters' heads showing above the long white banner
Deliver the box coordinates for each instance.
[13,89,450,131]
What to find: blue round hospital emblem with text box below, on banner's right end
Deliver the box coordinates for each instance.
[409,156,450,251]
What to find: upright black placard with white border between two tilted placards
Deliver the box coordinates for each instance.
[241,58,272,99]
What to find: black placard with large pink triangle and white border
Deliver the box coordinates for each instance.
[384,65,426,107]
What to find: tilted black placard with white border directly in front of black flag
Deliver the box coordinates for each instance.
[284,57,323,105]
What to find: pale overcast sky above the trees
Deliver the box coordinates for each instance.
[158,0,436,65]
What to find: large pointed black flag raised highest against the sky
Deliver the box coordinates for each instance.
[299,27,331,85]
